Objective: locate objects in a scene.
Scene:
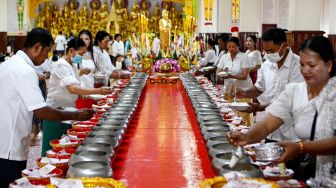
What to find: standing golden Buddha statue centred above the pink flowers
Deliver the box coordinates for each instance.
[159,9,172,54]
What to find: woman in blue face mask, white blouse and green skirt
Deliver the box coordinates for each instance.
[42,38,111,156]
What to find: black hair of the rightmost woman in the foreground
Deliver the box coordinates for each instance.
[299,36,336,77]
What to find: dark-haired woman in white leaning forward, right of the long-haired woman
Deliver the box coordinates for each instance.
[93,31,116,76]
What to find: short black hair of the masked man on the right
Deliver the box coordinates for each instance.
[261,28,287,45]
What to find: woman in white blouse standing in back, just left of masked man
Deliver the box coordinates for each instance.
[246,35,262,84]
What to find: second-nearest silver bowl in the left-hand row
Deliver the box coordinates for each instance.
[69,150,110,165]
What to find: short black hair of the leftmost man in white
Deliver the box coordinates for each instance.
[23,28,54,49]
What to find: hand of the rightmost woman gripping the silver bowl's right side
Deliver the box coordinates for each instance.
[277,142,300,163]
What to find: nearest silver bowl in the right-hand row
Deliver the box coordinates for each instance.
[220,163,264,178]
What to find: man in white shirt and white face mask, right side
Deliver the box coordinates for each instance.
[237,28,303,141]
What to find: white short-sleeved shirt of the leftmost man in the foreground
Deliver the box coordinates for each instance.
[0,51,46,161]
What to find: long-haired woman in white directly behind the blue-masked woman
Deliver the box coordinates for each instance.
[78,30,96,88]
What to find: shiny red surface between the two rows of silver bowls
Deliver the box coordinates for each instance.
[113,82,215,188]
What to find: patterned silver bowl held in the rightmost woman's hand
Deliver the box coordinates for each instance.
[254,143,284,162]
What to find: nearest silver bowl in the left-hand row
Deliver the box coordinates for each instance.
[67,161,113,178]
